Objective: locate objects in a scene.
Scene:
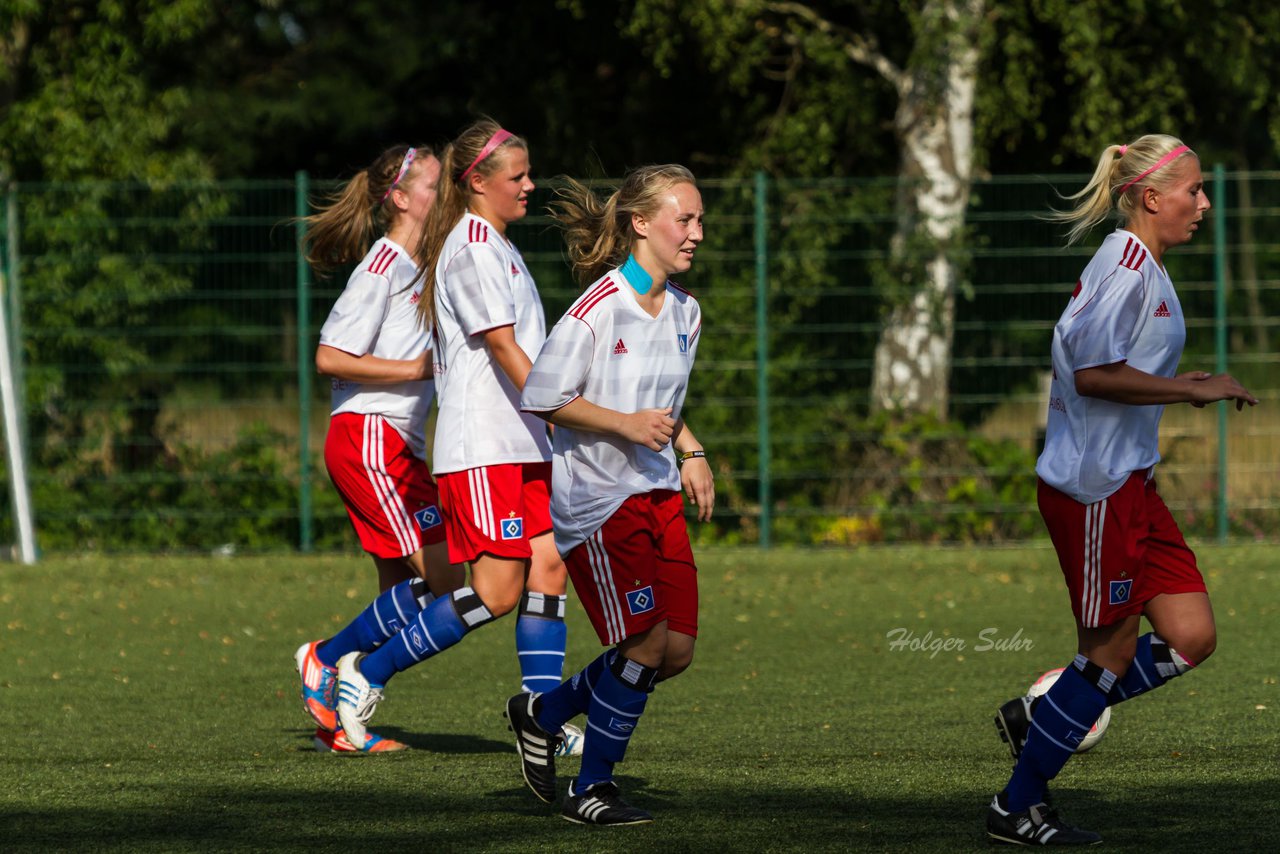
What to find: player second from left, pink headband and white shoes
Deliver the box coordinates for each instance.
[338,119,566,739]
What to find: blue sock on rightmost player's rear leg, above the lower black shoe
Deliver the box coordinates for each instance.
[1005,656,1116,813]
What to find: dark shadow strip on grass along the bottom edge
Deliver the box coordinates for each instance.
[0,778,1280,854]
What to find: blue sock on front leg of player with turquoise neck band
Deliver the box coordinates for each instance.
[573,656,658,791]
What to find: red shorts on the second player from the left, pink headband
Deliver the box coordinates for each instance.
[439,462,552,563]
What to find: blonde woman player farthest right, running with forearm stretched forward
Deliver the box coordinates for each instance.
[987,134,1257,845]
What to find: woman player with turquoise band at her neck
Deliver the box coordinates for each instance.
[507,165,716,825]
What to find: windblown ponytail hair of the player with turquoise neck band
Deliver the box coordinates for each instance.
[550,164,698,286]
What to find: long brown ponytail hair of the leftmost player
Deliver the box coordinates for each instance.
[301,145,434,274]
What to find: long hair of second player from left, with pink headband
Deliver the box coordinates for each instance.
[417,117,529,329]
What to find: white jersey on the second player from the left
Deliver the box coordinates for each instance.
[431,214,550,474]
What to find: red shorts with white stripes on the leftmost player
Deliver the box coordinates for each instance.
[324,412,444,557]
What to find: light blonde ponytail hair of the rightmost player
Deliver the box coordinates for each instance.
[1046,133,1196,246]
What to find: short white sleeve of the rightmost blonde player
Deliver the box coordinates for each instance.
[1062,269,1146,371]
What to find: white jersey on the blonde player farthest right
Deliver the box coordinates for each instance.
[1036,229,1187,504]
